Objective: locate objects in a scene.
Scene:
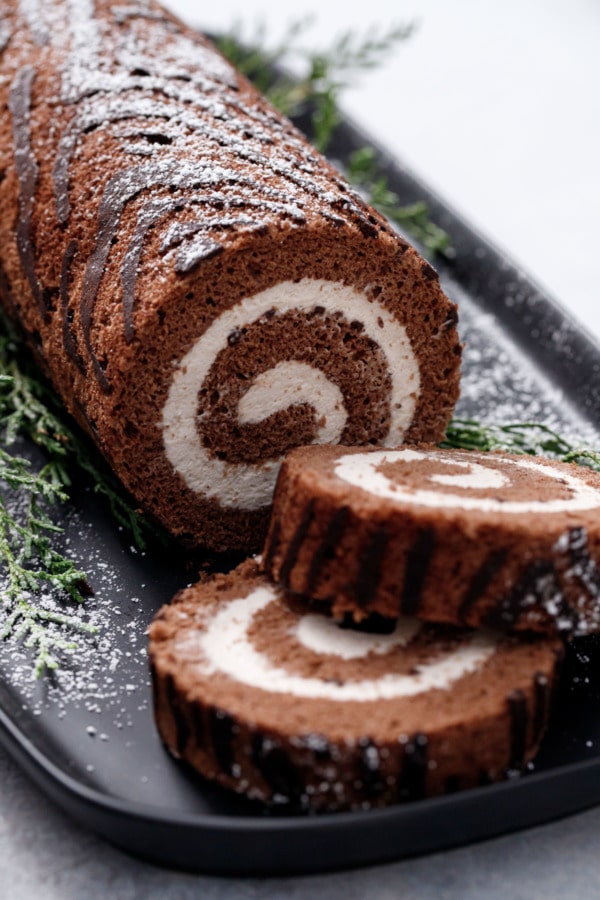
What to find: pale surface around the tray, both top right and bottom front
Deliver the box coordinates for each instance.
[0,0,600,900]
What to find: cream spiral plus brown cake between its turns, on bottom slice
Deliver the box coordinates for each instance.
[183,586,496,703]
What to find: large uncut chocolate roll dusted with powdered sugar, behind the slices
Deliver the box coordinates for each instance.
[0,0,460,549]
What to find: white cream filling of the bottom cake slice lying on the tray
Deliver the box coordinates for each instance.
[192,586,496,702]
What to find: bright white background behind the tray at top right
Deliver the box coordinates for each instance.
[168,0,600,337]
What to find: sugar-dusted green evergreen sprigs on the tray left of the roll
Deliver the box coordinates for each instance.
[0,316,156,675]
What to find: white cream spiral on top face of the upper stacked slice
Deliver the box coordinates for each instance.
[335,449,600,513]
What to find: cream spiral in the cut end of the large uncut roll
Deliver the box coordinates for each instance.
[160,278,420,510]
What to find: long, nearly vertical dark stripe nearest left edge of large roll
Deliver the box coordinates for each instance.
[8,66,48,319]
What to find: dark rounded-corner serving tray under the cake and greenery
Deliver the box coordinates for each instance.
[0,107,600,874]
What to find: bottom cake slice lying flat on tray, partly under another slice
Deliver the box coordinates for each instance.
[150,561,562,810]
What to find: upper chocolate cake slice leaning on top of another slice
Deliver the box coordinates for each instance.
[264,446,600,635]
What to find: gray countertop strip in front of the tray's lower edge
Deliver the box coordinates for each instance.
[0,732,600,900]
